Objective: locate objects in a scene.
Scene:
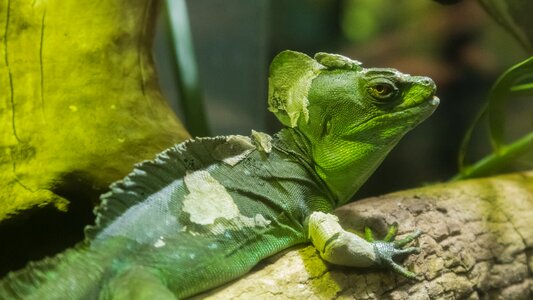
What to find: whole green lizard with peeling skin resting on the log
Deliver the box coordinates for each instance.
[0,51,439,299]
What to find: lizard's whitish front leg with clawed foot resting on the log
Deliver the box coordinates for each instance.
[308,212,422,278]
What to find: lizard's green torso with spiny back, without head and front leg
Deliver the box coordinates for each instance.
[0,133,330,299]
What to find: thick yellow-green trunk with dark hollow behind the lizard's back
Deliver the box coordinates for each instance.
[0,0,188,274]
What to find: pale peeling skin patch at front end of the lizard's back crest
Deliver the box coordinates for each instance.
[212,135,255,166]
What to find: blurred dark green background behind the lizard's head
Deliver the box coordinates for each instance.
[154,0,532,198]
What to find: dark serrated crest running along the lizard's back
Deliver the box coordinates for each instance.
[85,135,256,240]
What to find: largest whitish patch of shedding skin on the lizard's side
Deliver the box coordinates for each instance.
[183,170,271,234]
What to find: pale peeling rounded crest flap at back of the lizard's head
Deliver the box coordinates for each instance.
[268,50,324,127]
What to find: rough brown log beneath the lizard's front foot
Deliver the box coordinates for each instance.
[197,172,533,299]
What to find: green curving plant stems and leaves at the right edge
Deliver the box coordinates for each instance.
[454,0,533,180]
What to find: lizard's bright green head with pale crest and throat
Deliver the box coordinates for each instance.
[269,51,439,202]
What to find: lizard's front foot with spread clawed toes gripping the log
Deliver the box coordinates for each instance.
[365,222,422,279]
